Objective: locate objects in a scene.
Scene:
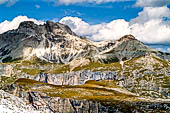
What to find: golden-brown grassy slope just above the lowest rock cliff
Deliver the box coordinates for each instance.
[15,78,138,101]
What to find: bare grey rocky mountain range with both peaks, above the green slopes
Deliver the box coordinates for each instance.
[0,21,167,64]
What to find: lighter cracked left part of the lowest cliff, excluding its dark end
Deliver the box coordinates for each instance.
[26,92,106,113]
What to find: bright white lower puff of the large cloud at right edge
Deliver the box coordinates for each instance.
[130,20,170,43]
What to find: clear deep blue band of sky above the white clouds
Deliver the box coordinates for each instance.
[0,0,142,24]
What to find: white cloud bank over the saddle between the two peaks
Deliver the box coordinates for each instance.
[60,17,130,41]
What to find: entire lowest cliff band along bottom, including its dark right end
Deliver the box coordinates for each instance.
[10,92,170,113]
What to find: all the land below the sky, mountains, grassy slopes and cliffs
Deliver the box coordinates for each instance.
[0,21,170,113]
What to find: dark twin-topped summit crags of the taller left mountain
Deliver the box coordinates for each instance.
[18,21,76,35]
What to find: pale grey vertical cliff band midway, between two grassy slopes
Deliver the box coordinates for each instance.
[34,70,117,85]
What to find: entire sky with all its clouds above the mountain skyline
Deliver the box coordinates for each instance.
[0,0,170,52]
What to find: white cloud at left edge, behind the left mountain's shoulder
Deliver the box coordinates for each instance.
[0,16,44,34]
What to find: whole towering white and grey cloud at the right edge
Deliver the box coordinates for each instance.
[130,6,170,43]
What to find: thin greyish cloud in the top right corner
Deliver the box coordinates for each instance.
[135,0,170,7]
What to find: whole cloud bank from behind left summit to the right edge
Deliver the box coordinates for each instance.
[60,6,170,44]
